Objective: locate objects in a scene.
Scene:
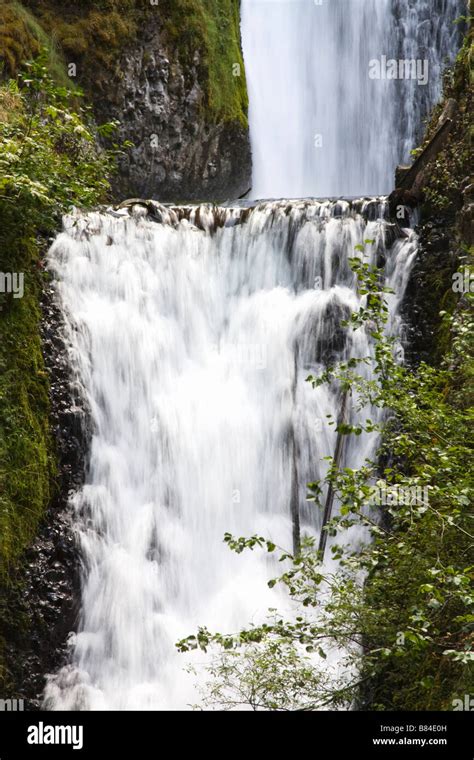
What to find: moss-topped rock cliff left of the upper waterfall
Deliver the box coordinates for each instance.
[0,0,251,202]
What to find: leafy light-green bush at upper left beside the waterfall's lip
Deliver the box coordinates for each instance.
[0,58,117,235]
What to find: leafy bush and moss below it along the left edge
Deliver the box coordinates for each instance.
[0,55,114,678]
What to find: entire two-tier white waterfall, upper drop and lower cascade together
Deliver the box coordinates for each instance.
[39,0,463,709]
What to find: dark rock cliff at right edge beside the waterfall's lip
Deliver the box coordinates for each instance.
[403,24,474,365]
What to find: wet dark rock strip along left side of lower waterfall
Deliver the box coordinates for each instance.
[2,270,90,709]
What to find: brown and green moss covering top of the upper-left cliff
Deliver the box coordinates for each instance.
[4,0,248,127]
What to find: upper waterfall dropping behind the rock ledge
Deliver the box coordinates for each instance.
[241,0,465,198]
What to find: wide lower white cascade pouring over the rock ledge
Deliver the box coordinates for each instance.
[46,200,416,709]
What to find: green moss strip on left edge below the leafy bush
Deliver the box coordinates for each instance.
[0,242,55,583]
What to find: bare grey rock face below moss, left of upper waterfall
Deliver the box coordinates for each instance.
[102,25,251,201]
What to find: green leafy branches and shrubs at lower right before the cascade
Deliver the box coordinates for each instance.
[177,258,474,710]
